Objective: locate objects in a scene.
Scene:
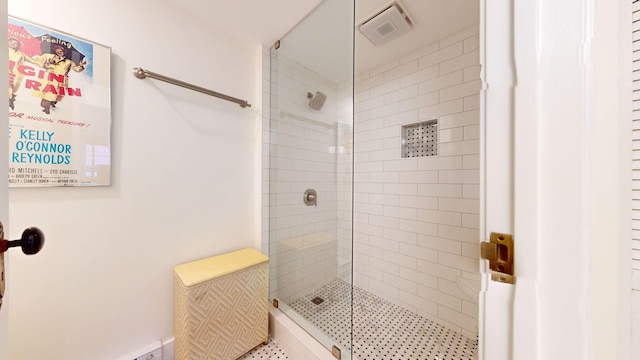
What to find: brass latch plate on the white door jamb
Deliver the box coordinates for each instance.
[480,233,516,284]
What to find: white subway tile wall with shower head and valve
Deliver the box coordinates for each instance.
[263,47,353,303]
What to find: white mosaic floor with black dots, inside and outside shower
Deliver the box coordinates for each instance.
[241,280,478,360]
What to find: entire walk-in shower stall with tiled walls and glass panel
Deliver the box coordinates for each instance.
[263,0,481,360]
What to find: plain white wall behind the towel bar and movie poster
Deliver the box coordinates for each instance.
[7,0,260,359]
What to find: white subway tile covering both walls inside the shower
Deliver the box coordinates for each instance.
[262,27,481,338]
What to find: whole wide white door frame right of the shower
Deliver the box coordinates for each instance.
[479,0,631,360]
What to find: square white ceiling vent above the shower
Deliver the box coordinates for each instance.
[359,2,413,46]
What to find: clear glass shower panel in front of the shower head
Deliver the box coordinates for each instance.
[267,0,354,359]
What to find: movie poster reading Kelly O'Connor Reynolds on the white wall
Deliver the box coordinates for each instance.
[8,16,111,187]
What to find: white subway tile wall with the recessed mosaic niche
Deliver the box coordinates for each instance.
[354,26,481,338]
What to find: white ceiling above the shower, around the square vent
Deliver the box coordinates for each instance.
[163,0,479,81]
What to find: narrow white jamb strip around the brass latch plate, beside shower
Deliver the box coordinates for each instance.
[478,0,517,360]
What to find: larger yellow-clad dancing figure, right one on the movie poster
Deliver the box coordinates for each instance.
[36,45,87,114]
